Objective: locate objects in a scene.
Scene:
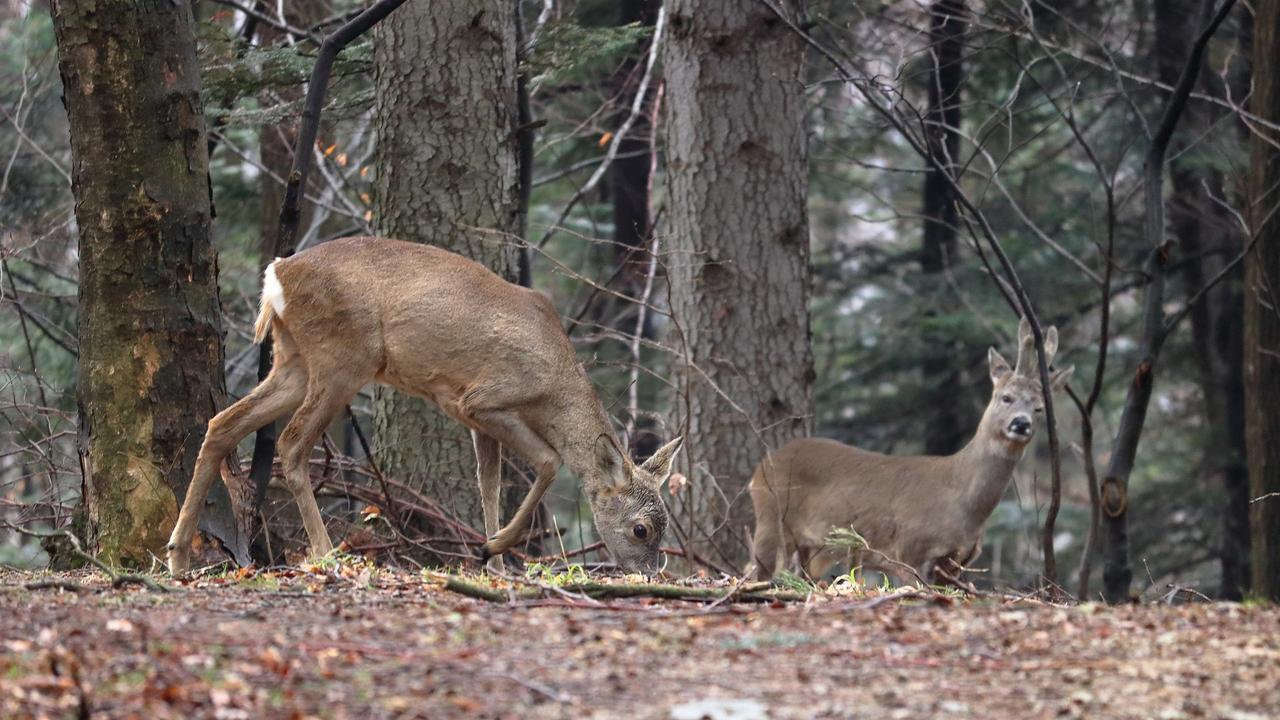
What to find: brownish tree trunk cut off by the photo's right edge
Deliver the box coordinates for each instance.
[1244,0,1280,602]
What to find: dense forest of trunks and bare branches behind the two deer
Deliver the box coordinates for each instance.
[0,0,1280,600]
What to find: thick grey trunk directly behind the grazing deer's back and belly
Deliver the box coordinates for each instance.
[374,0,518,528]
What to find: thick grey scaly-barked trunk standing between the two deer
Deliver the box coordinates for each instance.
[663,0,813,565]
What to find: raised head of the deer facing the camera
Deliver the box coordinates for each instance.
[979,318,1075,448]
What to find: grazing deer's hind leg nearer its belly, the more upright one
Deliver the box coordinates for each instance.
[280,366,366,557]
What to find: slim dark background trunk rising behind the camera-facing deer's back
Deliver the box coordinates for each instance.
[920,0,972,455]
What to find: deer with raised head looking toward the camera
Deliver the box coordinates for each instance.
[750,319,1074,583]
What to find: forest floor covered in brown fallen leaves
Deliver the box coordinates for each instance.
[0,566,1280,720]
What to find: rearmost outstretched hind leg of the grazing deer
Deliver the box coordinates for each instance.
[168,359,307,577]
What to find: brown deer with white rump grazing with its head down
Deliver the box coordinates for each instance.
[168,237,680,575]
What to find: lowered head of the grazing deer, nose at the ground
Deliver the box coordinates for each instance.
[582,434,681,574]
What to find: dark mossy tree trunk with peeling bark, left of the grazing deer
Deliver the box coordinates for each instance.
[52,0,246,564]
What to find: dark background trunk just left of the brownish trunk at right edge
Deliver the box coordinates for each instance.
[1155,0,1249,600]
